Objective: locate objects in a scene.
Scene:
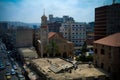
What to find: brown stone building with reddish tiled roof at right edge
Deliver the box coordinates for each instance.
[94,33,120,80]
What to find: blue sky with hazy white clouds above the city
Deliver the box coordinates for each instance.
[0,0,120,23]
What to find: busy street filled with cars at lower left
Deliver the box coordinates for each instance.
[0,42,25,80]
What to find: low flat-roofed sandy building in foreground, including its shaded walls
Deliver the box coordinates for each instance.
[30,58,108,80]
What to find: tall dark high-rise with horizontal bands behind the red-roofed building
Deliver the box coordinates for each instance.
[94,3,120,40]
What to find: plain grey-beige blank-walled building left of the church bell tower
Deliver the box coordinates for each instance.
[13,29,33,47]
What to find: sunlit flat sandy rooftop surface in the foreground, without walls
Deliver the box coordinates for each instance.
[31,58,106,80]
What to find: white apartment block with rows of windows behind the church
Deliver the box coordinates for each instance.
[60,22,86,46]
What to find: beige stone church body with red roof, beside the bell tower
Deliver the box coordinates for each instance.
[38,32,74,58]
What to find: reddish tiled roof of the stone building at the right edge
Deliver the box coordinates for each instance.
[94,33,120,47]
